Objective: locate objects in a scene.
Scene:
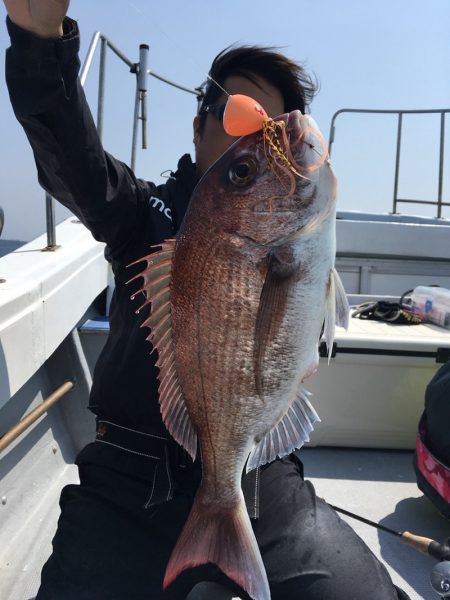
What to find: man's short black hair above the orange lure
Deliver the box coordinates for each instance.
[199,46,318,128]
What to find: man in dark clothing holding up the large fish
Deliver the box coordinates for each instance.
[5,0,407,600]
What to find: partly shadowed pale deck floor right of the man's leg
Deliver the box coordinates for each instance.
[302,448,450,600]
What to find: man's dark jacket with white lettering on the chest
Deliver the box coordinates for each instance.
[6,18,197,435]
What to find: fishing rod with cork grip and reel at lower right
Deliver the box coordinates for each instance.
[328,503,450,600]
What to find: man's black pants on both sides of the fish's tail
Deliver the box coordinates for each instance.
[37,443,408,600]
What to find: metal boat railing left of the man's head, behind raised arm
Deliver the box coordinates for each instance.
[45,31,203,250]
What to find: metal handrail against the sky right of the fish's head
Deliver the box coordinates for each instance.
[328,108,450,219]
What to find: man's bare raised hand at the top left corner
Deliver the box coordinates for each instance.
[4,0,70,38]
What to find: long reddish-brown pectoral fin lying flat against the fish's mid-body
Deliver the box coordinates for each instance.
[253,246,300,398]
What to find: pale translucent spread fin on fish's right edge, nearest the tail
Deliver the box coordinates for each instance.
[246,388,320,473]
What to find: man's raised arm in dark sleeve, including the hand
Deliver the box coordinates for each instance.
[5,0,160,255]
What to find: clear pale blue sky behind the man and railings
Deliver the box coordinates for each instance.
[0,0,450,240]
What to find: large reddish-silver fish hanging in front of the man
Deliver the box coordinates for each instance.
[128,111,348,600]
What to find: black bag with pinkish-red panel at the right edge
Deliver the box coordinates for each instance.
[414,361,450,519]
